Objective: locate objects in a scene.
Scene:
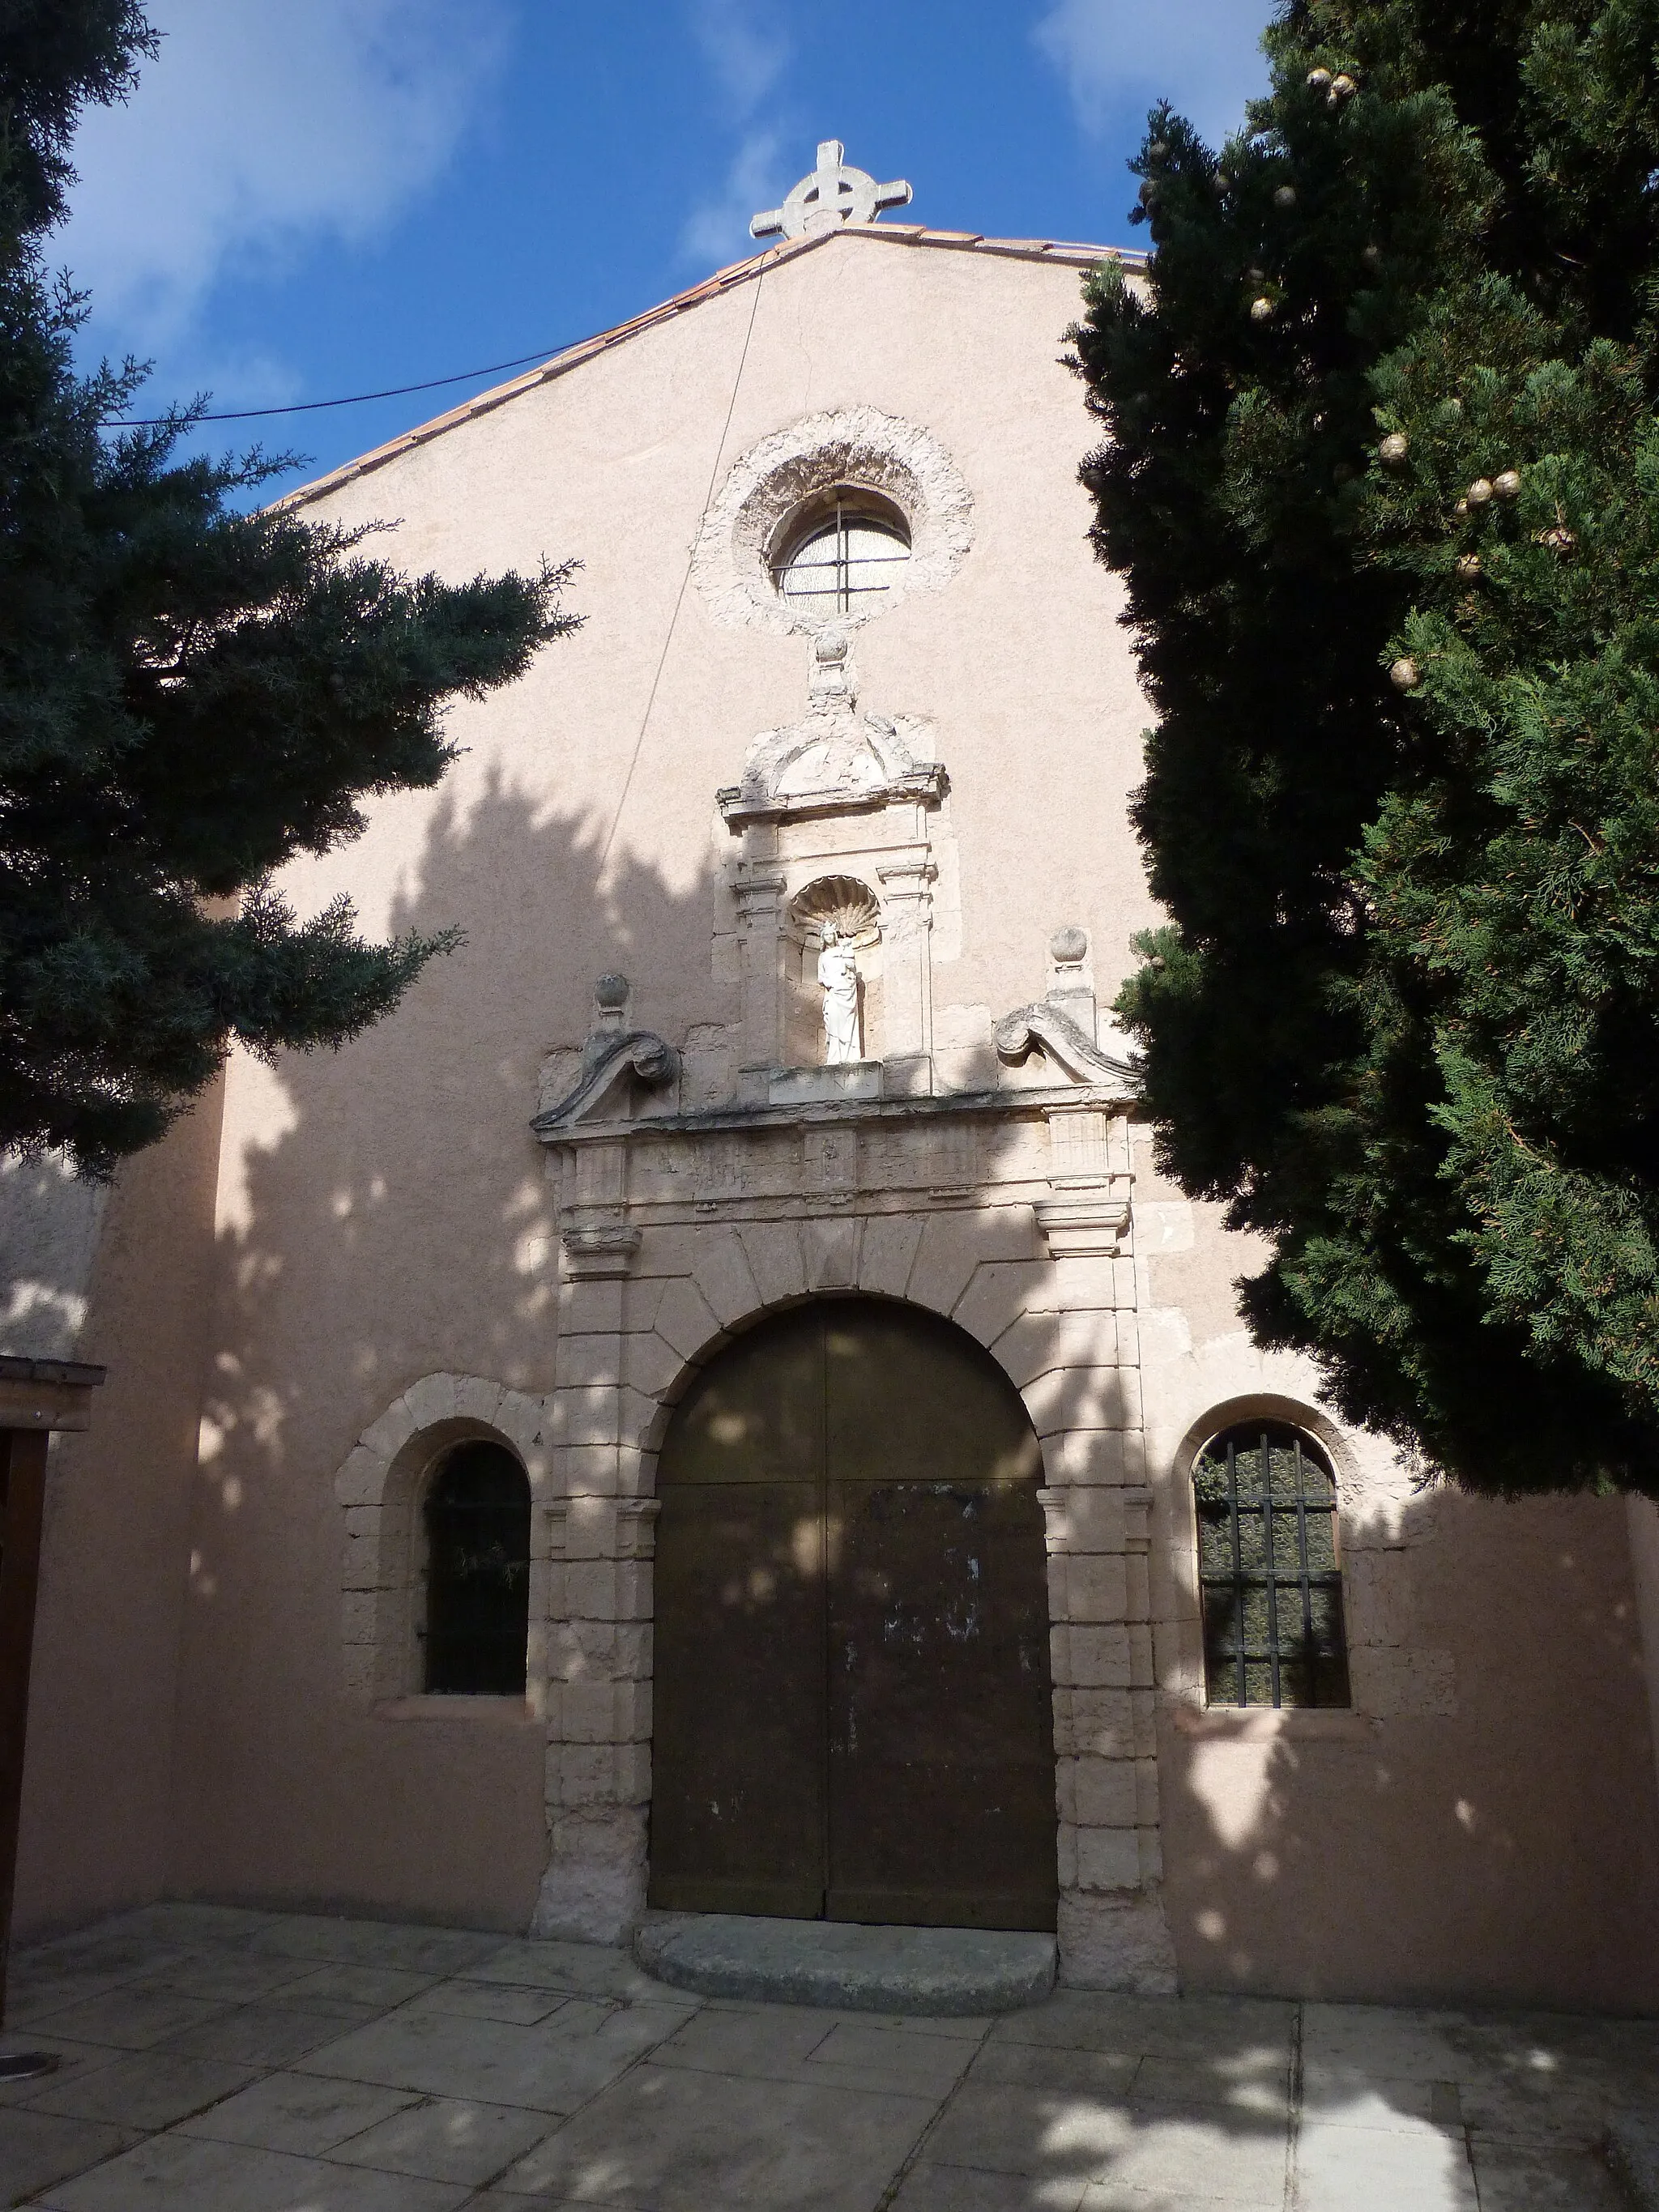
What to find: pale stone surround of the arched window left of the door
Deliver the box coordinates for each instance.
[334,1374,551,1719]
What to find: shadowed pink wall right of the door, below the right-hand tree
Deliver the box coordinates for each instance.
[1159,1489,1659,2010]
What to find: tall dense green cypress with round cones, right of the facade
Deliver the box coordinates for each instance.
[1077,0,1659,1495]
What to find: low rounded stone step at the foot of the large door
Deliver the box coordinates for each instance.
[633,1913,1056,2018]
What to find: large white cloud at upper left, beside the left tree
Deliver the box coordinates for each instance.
[53,0,505,352]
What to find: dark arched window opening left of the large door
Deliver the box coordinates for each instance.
[424,1443,531,1697]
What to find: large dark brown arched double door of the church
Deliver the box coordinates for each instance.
[650,1298,1057,1929]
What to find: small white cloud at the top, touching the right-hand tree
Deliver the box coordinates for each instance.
[1035,0,1274,144]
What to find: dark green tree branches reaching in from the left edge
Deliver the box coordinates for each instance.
[0,0,569,1174]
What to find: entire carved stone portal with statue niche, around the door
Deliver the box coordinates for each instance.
[533,606,1175,1991]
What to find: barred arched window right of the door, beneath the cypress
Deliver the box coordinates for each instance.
[1192,1420,1350,1706]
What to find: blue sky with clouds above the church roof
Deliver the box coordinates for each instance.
[55,0,1272,493]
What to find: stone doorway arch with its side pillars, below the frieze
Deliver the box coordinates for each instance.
[533,1203,1175,1991]
